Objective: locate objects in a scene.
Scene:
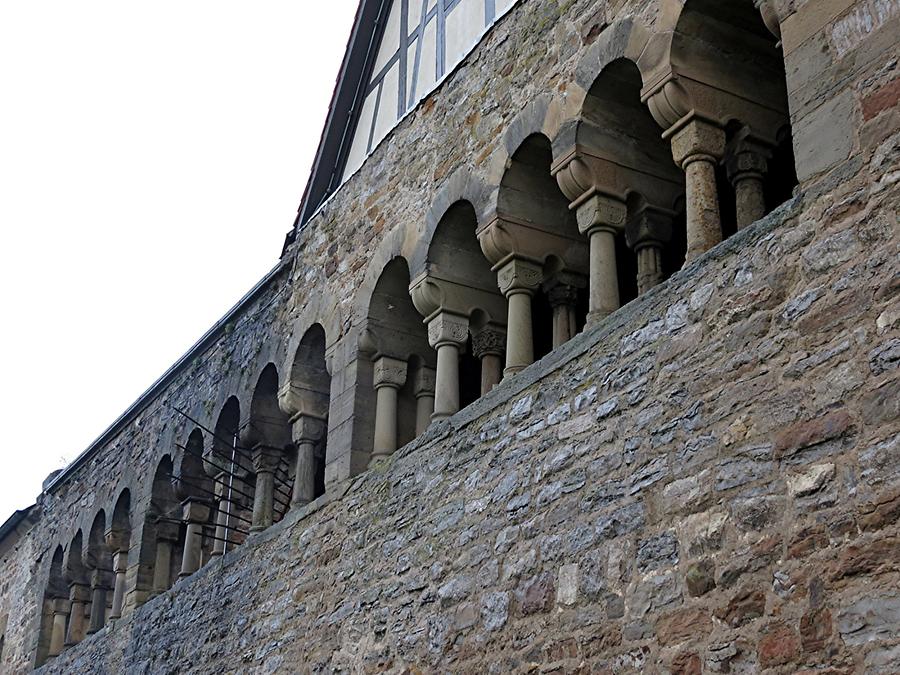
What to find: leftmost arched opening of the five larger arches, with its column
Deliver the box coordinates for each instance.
[366,257,435,458]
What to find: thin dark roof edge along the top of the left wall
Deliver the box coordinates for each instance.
[44,259,288,493]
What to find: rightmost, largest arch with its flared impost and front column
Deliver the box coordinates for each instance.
[642,0,797,242]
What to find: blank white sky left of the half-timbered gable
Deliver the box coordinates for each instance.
[0,0,358,523]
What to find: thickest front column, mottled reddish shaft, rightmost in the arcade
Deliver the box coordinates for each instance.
[667,118,725,263]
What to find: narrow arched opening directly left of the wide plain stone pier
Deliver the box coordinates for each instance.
[281,324,331,505]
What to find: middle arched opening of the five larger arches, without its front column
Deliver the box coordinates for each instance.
[497,134,588,360]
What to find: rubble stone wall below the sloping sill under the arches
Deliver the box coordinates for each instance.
[29,169,900,673]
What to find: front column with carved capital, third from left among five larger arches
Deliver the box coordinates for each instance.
[497,258,543,375]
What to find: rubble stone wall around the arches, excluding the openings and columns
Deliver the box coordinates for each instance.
[0,0,900,672]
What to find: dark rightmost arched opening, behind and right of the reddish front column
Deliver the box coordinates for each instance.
[671,0,797,231]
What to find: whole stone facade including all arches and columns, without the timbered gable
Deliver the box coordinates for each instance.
[0,0,900,675]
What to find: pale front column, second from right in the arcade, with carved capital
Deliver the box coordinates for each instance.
[576,193,627,324]
